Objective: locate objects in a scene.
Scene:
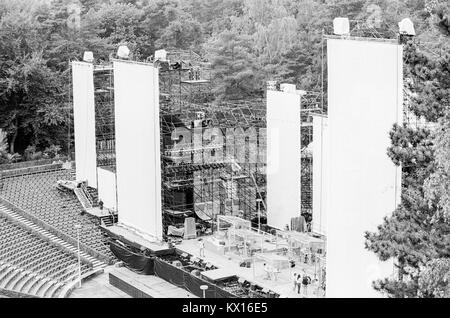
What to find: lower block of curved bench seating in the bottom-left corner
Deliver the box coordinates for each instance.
[0,215,92,297]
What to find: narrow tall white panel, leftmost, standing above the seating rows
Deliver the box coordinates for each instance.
[72,62,97,188]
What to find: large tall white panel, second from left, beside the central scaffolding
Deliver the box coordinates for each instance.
[114,61,162,239]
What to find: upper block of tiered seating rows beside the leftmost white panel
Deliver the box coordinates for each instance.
[0,169,114,259]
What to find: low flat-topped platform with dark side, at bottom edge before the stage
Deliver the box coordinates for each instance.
[109,267,197,298]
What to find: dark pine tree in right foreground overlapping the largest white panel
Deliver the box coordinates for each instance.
[366,1,450,297]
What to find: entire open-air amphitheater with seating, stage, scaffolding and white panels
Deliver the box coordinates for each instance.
[0,20,414,298]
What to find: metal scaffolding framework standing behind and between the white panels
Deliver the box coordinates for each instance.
[83,51,323,236]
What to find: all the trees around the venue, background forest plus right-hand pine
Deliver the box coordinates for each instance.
[0,0,450,297]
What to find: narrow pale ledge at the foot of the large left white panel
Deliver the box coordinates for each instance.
[101,225,170,254]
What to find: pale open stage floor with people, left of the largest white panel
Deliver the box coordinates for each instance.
[177,236,324,298]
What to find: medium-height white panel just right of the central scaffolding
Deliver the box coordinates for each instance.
[267,90,301,229]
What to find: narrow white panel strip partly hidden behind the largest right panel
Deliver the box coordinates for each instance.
[312,115,330,235]
